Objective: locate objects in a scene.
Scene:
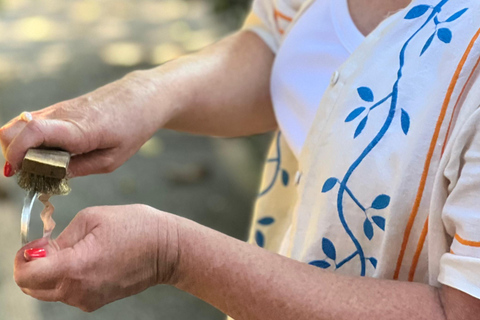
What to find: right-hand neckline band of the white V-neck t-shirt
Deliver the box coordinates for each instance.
[330,0,365,53]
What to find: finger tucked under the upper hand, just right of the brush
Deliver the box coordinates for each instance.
[68,149,121,178]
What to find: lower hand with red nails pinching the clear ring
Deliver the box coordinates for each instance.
[15,205,179,312]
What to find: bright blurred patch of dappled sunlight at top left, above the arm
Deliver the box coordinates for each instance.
[0,0,227,82]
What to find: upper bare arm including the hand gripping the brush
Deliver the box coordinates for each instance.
[0,31,276,176]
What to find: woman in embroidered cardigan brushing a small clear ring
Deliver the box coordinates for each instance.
[0,0,480,319]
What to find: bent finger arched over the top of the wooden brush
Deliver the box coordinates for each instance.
[5,119,95,169]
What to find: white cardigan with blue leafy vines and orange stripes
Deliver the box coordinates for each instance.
[244,0,480,310]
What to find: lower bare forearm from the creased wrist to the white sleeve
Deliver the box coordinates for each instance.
[175,218,478,320]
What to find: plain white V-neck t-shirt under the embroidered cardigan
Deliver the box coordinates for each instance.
[271,0,364,157]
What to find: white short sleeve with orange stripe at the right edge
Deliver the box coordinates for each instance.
[438,110,480,299]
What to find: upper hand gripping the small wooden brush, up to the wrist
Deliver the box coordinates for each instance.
[0,71,169,177]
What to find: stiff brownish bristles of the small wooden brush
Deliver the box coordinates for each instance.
[18,171,71,195]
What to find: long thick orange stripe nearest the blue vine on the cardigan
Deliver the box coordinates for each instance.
[393,29,480,280]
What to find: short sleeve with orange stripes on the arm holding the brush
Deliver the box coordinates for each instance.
[243,0,306,53]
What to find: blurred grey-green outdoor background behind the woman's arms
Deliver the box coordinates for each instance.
[0,0,270,320]
